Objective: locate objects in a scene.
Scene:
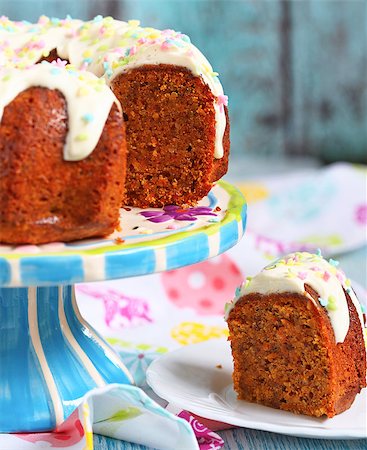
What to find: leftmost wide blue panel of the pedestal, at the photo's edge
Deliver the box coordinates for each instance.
[0,288,55,432]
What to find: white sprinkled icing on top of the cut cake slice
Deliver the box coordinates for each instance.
[226,252,364,343]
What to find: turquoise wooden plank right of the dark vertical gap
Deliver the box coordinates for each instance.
[292,0,367,162]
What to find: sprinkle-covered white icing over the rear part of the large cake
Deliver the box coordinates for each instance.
[0,16,228,158]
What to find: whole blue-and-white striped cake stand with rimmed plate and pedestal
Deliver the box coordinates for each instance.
[0,181,246,433]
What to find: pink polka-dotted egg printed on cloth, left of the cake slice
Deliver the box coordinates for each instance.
[161,255,243,316]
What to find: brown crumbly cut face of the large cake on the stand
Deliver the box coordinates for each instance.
[111,64,229,207]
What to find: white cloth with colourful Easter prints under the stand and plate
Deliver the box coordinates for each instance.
[0,163,367,450]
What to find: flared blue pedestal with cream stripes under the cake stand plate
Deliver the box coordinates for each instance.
[0,285,133,432]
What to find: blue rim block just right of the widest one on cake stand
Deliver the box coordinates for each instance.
[105,249,155,279]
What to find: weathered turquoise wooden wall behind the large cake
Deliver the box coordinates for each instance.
[0,0,367,162]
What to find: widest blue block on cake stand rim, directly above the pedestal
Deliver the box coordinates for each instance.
[20,255,84,285]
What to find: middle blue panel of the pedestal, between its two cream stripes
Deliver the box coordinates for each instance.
[37,286,96,418]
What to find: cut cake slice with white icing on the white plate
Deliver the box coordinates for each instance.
[226,253,366,417]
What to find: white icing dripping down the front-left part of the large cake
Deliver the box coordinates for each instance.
[0,61,120,161]
